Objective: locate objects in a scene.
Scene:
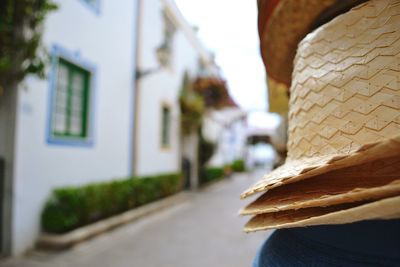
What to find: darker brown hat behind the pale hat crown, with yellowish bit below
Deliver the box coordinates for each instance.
[257,0,366,113]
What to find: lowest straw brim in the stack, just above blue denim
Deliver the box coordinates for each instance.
[244,196,400,232]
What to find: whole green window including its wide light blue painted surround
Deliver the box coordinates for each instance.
[47,45,96,146]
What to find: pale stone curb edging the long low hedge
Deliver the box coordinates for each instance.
[36,192,189,250]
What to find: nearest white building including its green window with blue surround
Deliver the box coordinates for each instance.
[0,0,137,254]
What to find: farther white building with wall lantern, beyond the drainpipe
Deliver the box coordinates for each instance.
[134,0,216,175]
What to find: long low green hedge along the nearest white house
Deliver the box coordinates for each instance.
[41,174,182,233]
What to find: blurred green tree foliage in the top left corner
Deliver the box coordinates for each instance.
[0,0,57,94]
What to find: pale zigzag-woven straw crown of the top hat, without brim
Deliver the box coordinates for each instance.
[288,0,400,159]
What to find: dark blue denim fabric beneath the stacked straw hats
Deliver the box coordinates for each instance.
[253,220,400,267]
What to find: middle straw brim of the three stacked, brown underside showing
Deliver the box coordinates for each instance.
[240,157,400,215]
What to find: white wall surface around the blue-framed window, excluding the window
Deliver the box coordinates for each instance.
[13,0,136,254]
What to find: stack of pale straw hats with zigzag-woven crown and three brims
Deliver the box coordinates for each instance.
[240,0,400,231]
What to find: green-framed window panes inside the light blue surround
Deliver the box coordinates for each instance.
[51,58,91,139]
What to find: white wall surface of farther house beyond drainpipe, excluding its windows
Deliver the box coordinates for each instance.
[135,0,209,175]
